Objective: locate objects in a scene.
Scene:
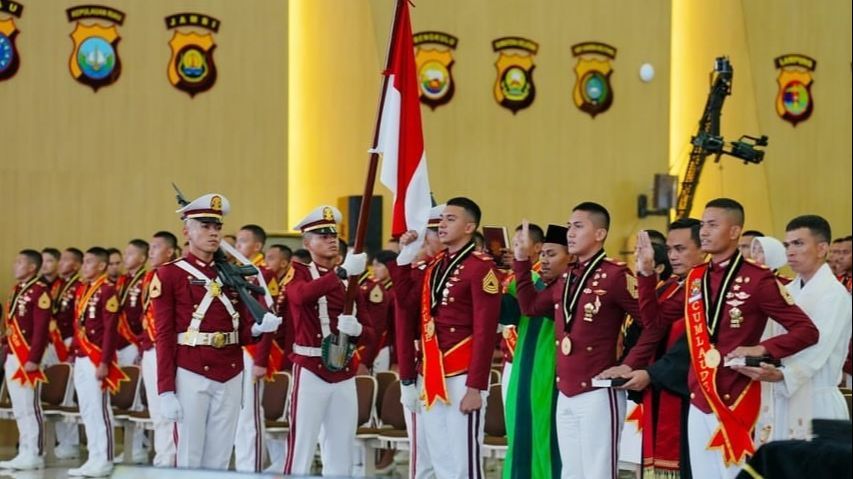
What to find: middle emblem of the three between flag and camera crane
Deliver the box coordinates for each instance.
[492,37,539,115]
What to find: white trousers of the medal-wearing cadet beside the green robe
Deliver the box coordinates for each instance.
[556,388,626,479]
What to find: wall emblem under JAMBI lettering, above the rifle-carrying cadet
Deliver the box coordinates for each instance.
[166,13,219,97]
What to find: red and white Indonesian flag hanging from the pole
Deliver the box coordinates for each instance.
[373,0,432,264]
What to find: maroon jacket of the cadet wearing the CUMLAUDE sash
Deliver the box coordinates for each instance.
[682,259,818,414]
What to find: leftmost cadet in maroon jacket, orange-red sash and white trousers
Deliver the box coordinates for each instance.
[0,249,51,470]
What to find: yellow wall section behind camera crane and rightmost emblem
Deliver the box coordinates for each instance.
[670,0,851,238]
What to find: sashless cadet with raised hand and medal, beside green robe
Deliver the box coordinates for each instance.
[513,202,654,478]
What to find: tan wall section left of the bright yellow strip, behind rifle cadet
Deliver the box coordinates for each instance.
[0,0,287,296]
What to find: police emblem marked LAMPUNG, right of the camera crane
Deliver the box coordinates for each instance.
[773,53,817,126]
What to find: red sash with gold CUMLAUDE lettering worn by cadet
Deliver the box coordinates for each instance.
[684,264,761,466]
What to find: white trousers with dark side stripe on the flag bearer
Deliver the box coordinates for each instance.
[284,364,358,476]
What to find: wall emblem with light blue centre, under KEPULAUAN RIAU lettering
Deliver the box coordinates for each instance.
[66,5,124,91]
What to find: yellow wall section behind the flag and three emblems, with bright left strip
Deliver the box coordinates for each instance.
[289,0,670,254]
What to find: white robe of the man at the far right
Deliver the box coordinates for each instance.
[756,264,853,445]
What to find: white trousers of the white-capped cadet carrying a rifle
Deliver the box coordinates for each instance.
[175,368,243,469]
